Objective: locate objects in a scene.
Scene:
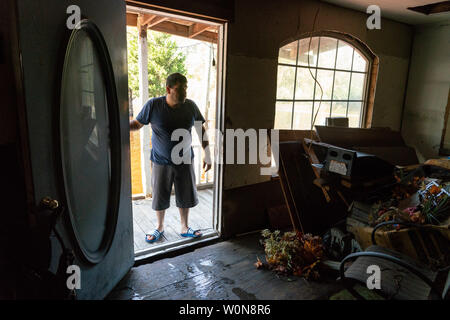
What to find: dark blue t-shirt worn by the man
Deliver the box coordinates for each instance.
[136,96,205,164]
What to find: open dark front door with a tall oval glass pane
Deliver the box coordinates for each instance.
[17,0,134,299]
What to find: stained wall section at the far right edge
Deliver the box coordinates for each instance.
[402,21,450,162]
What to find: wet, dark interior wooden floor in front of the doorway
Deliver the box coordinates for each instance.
[106,233,342,300]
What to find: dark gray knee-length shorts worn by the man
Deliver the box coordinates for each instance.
[152,162,198,211]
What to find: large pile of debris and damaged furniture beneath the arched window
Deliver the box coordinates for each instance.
[268,126,450,300]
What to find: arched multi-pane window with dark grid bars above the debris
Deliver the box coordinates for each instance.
[274,32,375,130]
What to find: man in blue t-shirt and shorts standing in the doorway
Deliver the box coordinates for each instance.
[130,73,211,243]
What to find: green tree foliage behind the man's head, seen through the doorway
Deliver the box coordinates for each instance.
[127,28,187,98]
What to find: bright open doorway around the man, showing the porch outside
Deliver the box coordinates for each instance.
[127,6,224,260]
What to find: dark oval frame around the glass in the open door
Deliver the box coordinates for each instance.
[54,19,121,264]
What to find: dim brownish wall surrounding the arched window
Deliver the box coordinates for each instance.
[224,0,413,190]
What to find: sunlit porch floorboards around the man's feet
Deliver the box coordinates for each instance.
[133,188,213,254]
